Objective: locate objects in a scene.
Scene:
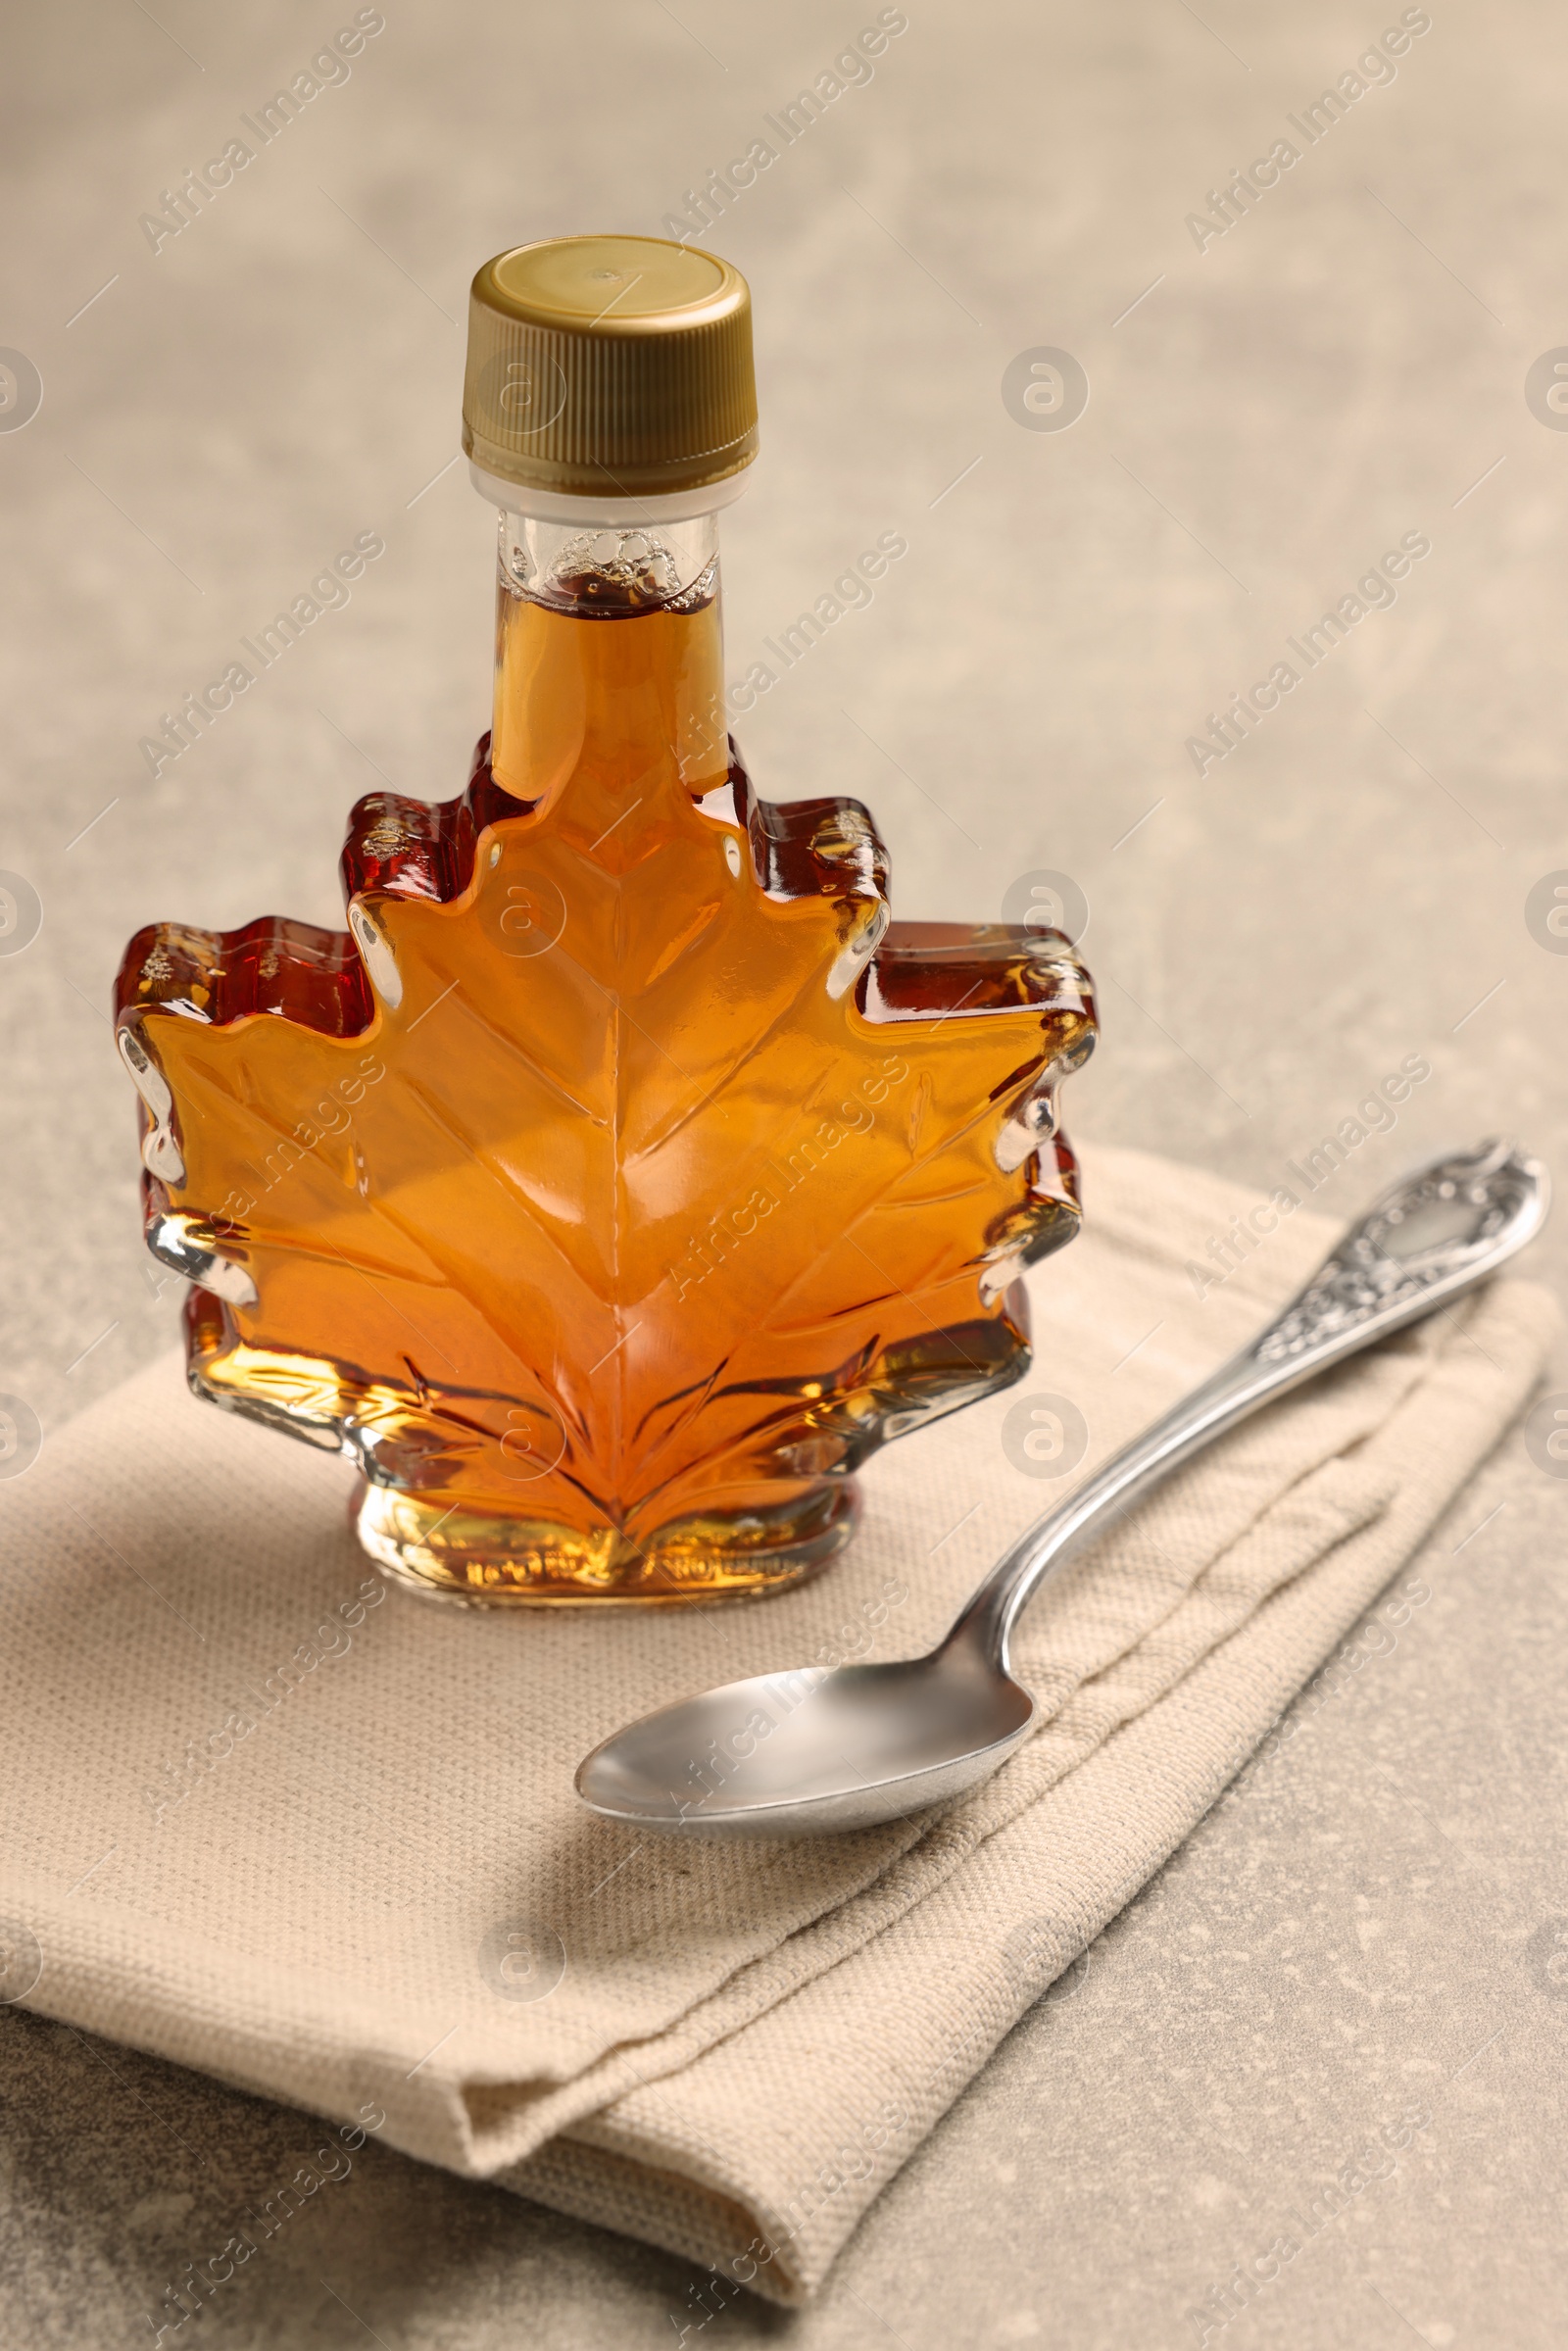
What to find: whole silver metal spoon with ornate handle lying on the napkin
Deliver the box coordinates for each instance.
[576,1143,1551,1837]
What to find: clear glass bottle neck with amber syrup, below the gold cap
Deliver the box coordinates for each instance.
[491,501,729,825]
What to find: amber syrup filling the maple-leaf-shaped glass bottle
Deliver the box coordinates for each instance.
[120,559,1093,1601]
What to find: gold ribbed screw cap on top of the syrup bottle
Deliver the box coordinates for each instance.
[464,237,757,499]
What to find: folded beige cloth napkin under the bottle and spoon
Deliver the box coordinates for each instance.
[0,1150,1554,2302]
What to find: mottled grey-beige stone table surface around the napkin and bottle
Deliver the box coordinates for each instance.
[0,0,1568,2351]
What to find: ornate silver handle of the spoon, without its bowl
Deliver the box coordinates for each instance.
[945,1143,1551,1672]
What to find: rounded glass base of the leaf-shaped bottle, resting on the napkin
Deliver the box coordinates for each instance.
[350,1477,860,1608]
